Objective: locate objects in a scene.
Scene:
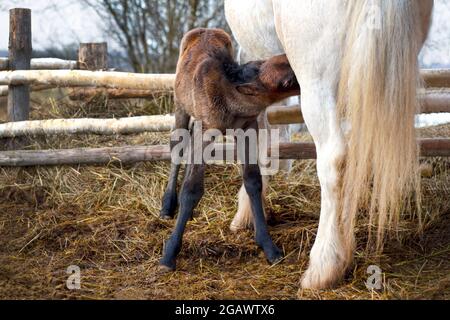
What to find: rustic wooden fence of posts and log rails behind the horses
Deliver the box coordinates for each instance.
[0,9,450,166]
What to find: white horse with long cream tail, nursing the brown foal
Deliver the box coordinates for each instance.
[225,0,433,289]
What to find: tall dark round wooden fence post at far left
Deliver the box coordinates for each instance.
[8,9,33,122]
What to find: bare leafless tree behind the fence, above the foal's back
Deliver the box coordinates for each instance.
[84,0,227,72]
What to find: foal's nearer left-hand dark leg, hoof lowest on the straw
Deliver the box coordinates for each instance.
[160,164,205,271]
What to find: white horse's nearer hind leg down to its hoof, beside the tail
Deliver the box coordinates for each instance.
[302,81,353,289]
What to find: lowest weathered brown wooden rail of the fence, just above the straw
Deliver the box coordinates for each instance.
[0,139,450,167]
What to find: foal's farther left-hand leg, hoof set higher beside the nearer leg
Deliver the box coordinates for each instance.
[160,110,190,220]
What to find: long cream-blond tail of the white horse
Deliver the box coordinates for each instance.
[338,0,428,249]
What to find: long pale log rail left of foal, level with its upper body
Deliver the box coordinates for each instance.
[0,70,175,91]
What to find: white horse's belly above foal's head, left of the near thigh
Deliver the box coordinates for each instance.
[225,0,284,60]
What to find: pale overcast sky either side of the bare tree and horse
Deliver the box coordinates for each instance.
[0,0,450,67]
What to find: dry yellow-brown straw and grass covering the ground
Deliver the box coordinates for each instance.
[0,92,450,299]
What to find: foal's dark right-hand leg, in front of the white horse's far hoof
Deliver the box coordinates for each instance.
[243,124,283,264]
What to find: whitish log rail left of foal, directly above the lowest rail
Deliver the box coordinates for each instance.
[0,115,175,138]
